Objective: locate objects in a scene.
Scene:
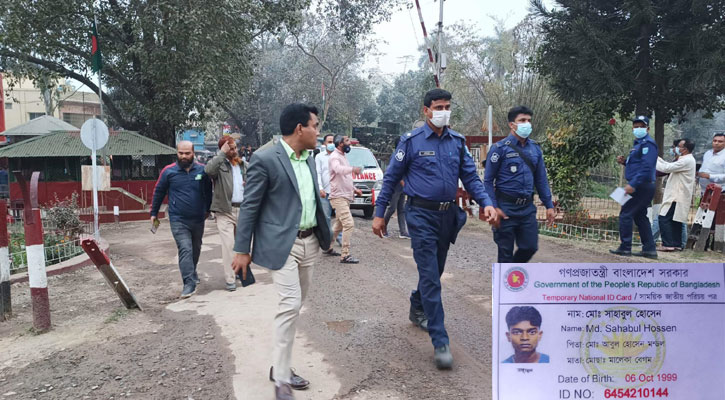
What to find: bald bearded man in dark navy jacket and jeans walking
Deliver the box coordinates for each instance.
[151,140,212,299]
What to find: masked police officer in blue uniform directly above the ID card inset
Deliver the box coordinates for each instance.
[483,106,556,263]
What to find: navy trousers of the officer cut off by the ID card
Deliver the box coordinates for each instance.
[493,199,539,263]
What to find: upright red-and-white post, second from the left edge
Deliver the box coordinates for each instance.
[23,208,50,332]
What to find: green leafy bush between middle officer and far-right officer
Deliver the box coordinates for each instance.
[543,103,615,213]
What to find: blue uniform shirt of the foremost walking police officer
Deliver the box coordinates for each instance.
[375,123,492,218]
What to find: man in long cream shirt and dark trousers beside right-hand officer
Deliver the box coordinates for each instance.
[657,139,696,251]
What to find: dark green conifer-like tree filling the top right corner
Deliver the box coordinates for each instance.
[531,0,725,152]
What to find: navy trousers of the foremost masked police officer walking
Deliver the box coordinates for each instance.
[405,203,466,348]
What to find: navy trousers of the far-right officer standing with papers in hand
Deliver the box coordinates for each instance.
[619,182,657,251]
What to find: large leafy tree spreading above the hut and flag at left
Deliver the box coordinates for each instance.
[0,0,309,144]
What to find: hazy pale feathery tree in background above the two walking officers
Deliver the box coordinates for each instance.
[432,20,559,138]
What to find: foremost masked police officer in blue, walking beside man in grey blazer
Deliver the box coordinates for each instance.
[373,89,496,369]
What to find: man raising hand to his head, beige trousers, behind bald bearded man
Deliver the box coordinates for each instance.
[204,135,244,292]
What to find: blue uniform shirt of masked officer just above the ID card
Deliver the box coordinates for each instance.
[483,134,554,208]
